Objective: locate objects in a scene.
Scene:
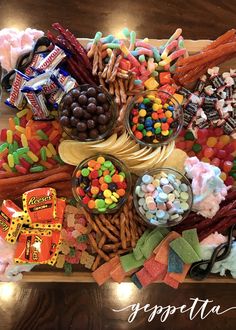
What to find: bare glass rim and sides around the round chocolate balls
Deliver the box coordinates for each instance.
[59,84,118,142]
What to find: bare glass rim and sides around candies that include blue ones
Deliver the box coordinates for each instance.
[125,90,183,148]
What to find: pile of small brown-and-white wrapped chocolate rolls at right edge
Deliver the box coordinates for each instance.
[179,67,236,136]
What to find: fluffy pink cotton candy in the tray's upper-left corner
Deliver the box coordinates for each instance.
[0,28,44,71]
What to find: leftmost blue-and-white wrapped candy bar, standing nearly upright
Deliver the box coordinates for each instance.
[5,70,30,109]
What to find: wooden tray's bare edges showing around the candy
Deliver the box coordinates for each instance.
[0,38,236,284]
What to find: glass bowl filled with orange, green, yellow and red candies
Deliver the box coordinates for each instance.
[72,154,131,213]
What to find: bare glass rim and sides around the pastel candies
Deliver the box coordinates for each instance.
[133,167,193,228]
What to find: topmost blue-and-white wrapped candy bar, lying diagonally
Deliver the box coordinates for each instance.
[36,46,66,71]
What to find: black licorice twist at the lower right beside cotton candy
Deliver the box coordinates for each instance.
[189,224,236,281]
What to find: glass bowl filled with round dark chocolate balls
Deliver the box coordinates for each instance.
[59,85,117,142]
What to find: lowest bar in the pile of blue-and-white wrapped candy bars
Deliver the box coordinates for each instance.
[22,87,54,120]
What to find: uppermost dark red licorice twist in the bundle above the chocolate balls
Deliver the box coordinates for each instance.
[52,23,92,70]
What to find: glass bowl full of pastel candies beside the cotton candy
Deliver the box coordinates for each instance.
[133,168,193,227]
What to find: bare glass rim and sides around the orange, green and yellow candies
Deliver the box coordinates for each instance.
[72,154,132,214]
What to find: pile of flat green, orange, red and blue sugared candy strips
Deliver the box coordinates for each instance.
[92,228,200,288]
